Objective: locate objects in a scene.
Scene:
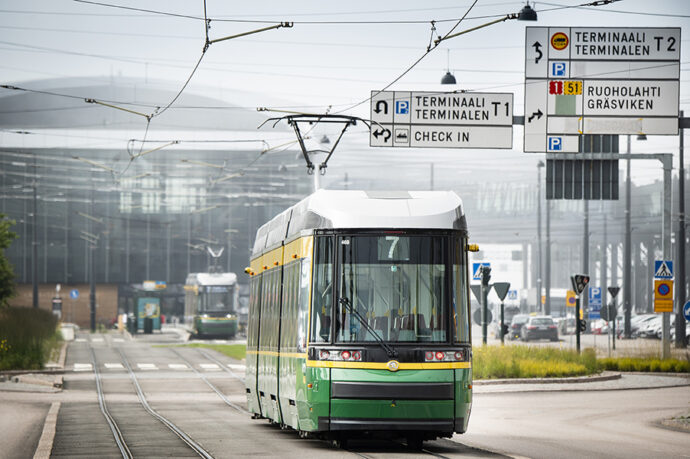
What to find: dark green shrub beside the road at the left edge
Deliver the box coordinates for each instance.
[0,308,58,370]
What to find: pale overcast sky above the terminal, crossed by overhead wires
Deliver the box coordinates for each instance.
[0,0,690,182]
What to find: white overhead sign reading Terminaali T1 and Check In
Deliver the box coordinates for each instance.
[369,91,513,149]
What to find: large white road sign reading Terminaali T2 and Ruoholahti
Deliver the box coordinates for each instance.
[524,27,681,153]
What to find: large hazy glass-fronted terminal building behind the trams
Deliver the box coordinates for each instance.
[0,79,687,326]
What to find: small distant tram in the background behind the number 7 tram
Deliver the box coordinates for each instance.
[184,273,239,338]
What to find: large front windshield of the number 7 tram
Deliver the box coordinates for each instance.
[335,234,466,343]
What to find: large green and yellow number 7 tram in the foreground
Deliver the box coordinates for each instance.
[246,190,472,448]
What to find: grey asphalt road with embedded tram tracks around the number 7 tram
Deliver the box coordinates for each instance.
[0,333,690,459]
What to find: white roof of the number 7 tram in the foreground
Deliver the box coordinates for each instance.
[252,190,467,256]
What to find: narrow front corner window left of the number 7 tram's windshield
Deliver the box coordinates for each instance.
[310,237,333,343]
